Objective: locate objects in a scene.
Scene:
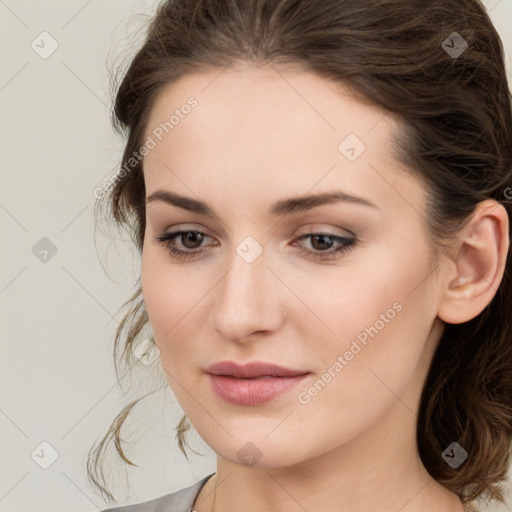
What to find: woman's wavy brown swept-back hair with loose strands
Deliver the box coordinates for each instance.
[87,0,512,502]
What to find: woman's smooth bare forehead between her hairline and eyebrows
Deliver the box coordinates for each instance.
[144,66,424,216]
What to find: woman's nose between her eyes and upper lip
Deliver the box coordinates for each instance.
[210,244,283,343]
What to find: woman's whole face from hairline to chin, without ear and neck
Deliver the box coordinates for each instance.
[142,66,448,467]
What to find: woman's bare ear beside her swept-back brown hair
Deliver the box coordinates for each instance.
[438,199,509,324]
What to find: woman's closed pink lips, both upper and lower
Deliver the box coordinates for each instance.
[206,361,311,406]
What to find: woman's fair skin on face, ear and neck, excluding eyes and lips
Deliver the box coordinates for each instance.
[142,64,508,512]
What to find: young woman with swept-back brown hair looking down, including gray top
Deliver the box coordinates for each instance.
[89,0,512,512]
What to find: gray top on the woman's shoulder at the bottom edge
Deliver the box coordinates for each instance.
[102,473,215,512]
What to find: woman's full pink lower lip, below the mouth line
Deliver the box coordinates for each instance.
[208,374,309,405]
